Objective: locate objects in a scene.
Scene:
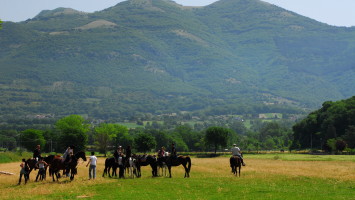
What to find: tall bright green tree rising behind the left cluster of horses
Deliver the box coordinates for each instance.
[55,115,90,151]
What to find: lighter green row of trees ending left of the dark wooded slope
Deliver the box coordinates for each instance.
[0,115,292,154]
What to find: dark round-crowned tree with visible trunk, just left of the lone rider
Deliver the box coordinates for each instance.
[205,126,231,153]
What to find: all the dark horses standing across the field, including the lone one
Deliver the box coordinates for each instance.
[23,151,242,181]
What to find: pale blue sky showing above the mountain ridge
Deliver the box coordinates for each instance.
[0,0,355,26]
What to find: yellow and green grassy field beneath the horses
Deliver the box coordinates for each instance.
[0,154,355,200]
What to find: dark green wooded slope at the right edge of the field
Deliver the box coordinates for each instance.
[292,96,355,151]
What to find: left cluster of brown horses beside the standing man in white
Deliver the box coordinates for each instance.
[27,151,86,181]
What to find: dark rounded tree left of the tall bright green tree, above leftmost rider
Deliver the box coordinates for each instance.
[21,129,46,151]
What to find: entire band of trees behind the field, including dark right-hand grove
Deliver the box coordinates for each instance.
[0,97,355,154]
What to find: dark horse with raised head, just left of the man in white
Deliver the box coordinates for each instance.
[49,151,86,182]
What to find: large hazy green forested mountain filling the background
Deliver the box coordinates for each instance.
[0,0,355,119]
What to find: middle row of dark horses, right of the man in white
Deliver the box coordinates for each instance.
[102,155,191,178]
